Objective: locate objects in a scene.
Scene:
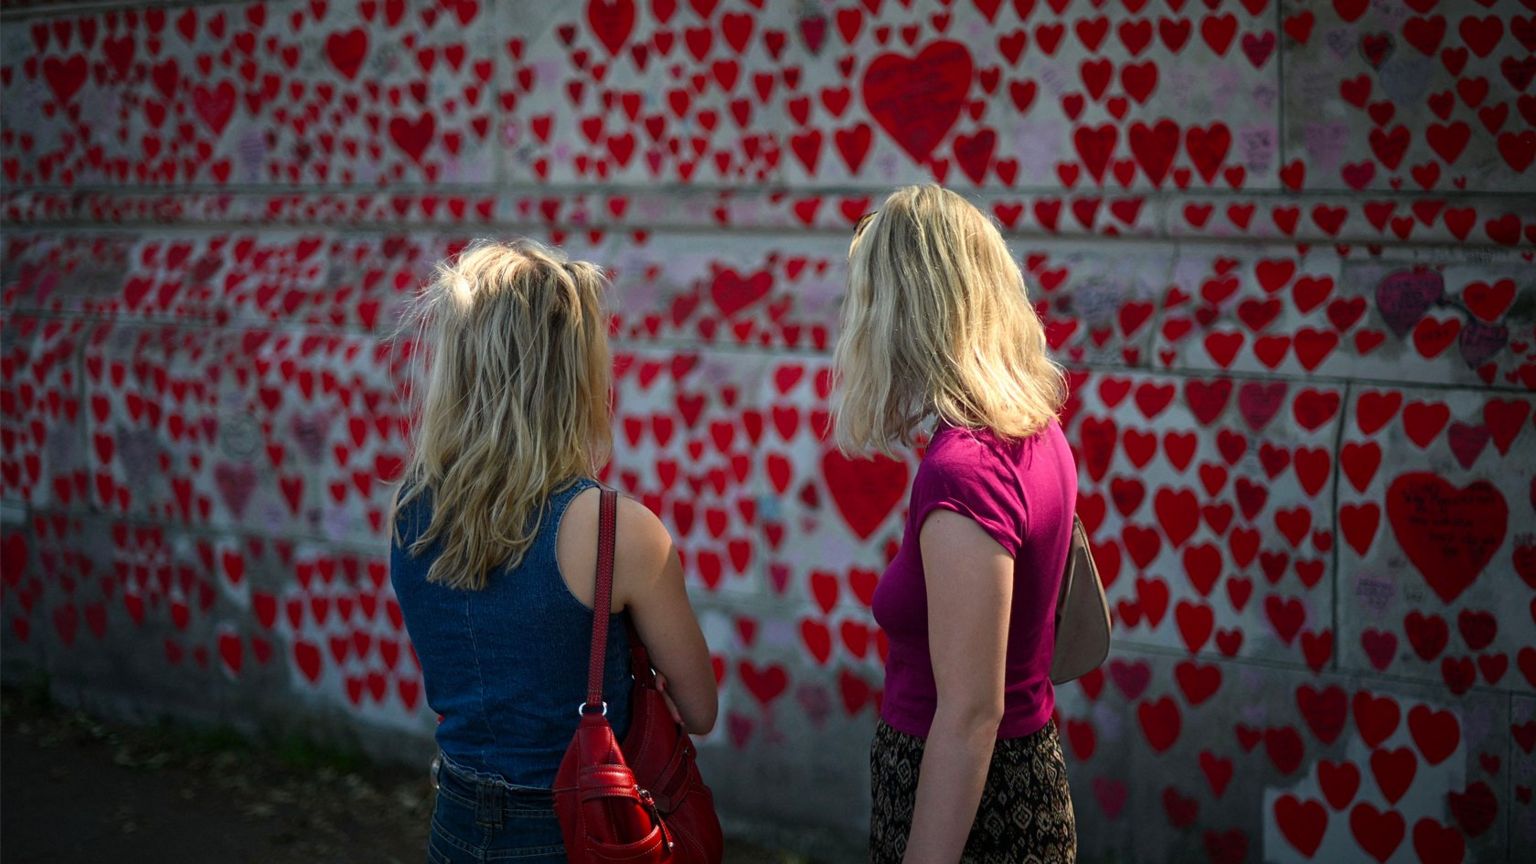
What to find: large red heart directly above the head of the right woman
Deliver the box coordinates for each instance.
[863,40,971,161]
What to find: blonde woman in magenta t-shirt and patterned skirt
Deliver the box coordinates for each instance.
[836,186,1077,864]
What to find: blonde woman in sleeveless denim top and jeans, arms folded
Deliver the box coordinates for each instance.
[390,240,716,864]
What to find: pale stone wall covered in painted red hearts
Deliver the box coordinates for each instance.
[0,0,1536,862]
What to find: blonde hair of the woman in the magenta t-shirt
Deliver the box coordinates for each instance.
[834,184,1066,452]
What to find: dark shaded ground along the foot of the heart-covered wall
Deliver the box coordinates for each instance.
[0,689,794,864]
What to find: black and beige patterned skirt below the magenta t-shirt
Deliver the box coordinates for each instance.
[869,721,1077,864]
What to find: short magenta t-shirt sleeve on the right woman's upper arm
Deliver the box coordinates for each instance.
[912,441,1026,558]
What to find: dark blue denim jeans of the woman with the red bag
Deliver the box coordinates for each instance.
[427,755,565,864]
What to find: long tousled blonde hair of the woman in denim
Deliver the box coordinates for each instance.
[395,240,613,589]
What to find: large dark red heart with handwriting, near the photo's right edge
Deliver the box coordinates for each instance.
[1387,472,1510,603]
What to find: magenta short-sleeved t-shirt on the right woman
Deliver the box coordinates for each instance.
[874,420,1077,738]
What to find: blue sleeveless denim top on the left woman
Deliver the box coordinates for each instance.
[390,478,634,789]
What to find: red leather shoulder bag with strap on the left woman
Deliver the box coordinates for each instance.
[554,489,725,864]
